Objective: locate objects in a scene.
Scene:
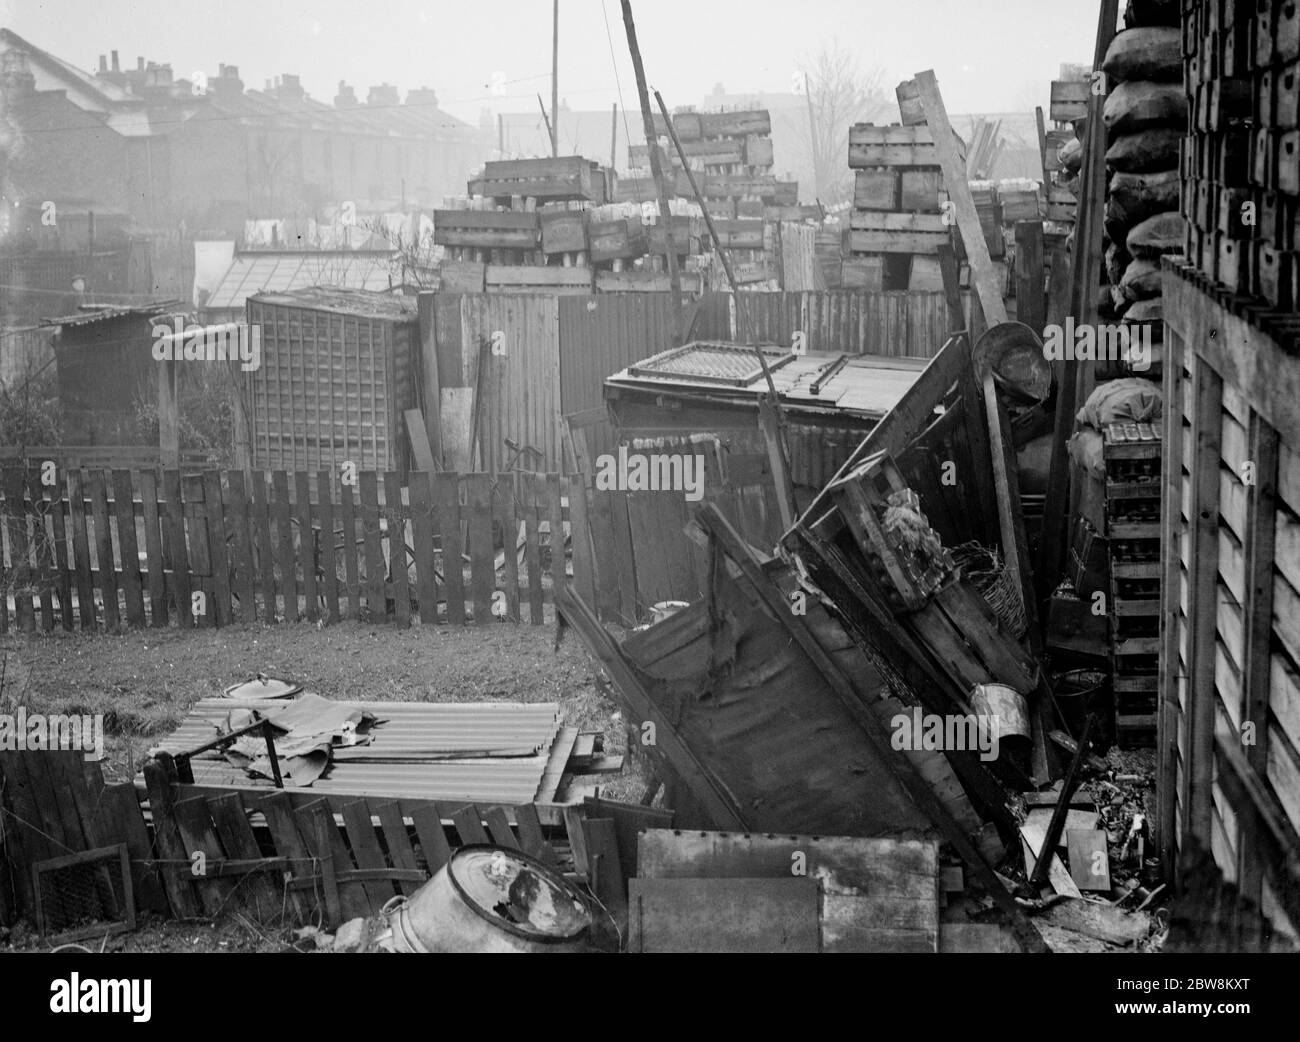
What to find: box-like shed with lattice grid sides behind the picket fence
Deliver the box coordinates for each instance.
[244,287,420,474]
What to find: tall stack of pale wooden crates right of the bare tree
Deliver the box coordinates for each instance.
[842,123,953,291]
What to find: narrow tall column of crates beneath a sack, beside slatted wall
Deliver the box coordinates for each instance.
[1102,424,1164,746]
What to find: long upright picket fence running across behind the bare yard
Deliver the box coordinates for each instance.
[0,466,594,633]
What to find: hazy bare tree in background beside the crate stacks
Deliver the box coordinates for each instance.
[801,44,898,205]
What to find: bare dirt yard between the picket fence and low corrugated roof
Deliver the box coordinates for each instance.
[0,613,638,798]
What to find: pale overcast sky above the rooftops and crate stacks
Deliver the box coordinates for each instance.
[0,0,1097,122]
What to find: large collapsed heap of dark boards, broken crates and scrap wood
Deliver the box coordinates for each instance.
[559,320,1152,950]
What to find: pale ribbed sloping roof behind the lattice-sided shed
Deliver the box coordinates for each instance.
[203,249,395,311]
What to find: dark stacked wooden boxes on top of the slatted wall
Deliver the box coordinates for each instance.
[1182,0,1300,312]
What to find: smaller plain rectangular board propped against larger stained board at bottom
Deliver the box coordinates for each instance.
[628,877,822,952]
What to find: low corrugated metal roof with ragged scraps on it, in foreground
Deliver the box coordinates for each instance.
[161,698,560,804]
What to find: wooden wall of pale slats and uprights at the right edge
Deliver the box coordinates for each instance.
[1157,272,1300,933]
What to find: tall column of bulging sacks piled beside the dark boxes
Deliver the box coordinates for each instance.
[1102,0,1187,335]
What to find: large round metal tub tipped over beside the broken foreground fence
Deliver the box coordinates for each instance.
[387,845,592,952]
